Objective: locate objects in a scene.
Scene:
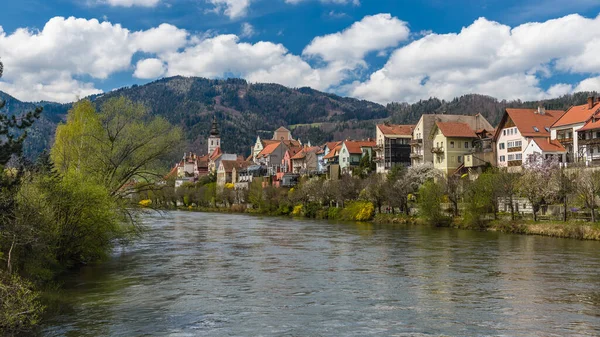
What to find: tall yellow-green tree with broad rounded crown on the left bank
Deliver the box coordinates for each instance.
[51,97,182,199]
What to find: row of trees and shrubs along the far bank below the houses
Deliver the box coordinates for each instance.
[137,155,600,240]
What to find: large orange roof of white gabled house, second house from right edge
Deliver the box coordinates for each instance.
[498,109,565,137]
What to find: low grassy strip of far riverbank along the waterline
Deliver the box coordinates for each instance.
[163,203,600,241]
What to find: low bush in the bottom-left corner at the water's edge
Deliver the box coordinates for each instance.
[0,271,44,334]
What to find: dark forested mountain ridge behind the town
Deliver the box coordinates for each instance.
[0,76,595,158]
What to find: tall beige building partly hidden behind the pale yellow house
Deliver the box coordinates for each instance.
[410,114,494,166]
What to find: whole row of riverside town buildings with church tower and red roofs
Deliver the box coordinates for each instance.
[169,97,600,189]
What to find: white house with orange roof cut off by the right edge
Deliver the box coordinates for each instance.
[550,96,600,163]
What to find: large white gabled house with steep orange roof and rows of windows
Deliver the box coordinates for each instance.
[494,107,565,171]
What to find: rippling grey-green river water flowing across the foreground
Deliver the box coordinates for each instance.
[40,212,600,336]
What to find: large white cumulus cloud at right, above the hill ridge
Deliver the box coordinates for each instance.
[350,15,600,102]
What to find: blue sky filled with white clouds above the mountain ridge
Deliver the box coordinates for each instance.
[0,0,600,104]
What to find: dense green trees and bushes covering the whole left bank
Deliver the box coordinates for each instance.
[0,60,182,335]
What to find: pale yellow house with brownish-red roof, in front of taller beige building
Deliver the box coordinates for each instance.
[431,122,478,175]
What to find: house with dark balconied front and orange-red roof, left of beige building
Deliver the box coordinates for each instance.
[375,124,415,173]
